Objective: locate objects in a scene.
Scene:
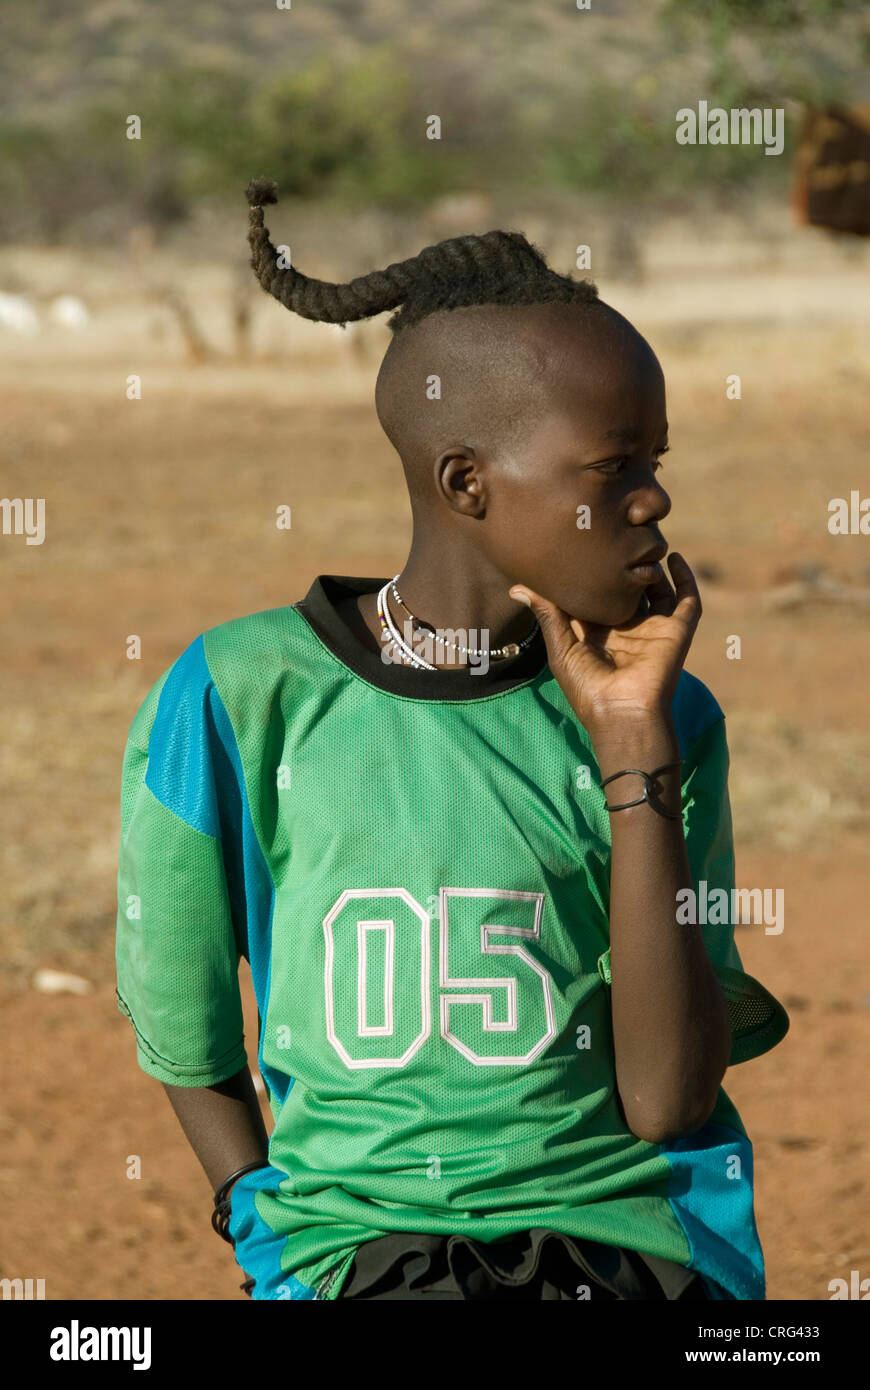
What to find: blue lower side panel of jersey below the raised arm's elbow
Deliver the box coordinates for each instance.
[659,1120,764,1298]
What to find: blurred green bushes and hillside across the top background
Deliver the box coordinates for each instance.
[0,0,870,239]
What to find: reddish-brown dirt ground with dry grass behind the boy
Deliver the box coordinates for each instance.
[0,208,870,1300]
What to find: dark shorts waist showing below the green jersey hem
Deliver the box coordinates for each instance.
[339,1229,709,1302]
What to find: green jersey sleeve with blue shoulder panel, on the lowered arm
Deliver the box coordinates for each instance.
[115,638,247,1086]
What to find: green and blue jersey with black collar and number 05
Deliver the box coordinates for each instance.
[117,575,788,1298]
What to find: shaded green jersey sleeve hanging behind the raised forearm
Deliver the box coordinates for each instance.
[669,716,788,1066]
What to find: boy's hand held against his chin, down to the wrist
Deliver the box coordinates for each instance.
[510,552,700,737]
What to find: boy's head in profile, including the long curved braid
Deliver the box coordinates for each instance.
[247,182,670,626]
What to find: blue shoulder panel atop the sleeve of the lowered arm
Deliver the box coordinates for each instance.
[145,637,221,835]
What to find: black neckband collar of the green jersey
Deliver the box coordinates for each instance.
[293,574,548,701]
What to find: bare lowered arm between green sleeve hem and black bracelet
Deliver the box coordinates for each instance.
[165,1066,268,1190]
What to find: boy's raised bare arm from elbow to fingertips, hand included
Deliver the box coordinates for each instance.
[509,553,731,1143]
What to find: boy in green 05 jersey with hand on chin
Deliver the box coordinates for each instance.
[117,182,788,1300]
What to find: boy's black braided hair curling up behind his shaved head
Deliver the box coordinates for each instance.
[245,178,600,334]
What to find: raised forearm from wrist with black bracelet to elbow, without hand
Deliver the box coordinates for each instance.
[595,713,731,1141]
